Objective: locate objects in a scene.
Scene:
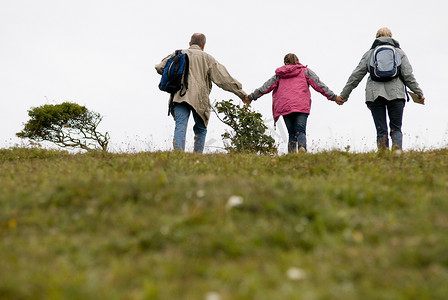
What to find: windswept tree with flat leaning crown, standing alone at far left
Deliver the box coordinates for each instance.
[16,102,110,151]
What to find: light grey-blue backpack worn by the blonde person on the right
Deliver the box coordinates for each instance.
[369,45,401,82]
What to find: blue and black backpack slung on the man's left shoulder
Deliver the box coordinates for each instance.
[159,50,190,97]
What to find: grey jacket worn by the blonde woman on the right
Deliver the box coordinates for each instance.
[341,37,423,102]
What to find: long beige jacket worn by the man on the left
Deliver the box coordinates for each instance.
[156,45,246,126]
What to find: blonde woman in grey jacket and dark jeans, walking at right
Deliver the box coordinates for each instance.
[341,27,425,151]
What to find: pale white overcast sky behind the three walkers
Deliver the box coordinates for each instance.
[0,0,448,152]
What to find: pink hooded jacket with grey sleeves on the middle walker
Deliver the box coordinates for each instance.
[249,63,336,124]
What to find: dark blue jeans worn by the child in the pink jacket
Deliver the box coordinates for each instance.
[283,112,308,153]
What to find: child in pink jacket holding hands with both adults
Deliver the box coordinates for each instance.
[244,53,344,153]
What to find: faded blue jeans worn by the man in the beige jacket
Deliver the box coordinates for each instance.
[173,102,207,153]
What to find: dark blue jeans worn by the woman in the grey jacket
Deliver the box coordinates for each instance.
[367,97,405,150]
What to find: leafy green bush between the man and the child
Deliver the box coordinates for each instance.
[215,100,277,154]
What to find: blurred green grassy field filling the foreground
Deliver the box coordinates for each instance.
[0,148,448,300]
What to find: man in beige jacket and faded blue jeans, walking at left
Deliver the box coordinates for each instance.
[156,33,246,153]
